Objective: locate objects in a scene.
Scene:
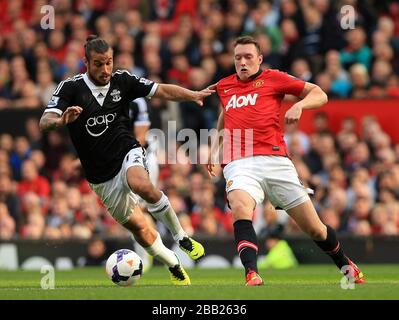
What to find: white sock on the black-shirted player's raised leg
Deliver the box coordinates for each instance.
[147,191,187,242]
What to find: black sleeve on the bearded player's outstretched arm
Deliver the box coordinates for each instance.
[116,70,158,100]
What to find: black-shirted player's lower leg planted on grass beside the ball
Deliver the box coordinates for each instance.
[123,205,190,285]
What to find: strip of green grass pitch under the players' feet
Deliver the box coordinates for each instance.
[0,264,399,300]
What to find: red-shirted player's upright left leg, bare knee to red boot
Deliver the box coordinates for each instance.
[227,189,263,286]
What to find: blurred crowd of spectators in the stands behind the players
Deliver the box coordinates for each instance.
[0,0,399,239]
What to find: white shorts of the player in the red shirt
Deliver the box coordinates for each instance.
[223,156,311,210]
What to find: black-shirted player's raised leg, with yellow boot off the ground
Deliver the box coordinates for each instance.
[126,156,205,260]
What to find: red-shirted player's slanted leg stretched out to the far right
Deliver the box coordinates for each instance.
[287,200,365,283]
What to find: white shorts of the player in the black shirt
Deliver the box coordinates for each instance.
[89,147,148,224]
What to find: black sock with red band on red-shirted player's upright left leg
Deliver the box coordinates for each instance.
[233,220,258,273]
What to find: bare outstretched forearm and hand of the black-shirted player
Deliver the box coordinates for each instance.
[154,83,215,106]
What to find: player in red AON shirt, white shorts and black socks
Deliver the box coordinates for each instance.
[208,36,365,286]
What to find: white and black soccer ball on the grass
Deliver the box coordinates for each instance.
[105,249,143,287]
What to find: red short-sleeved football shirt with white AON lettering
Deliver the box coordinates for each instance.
[216,69,305,164]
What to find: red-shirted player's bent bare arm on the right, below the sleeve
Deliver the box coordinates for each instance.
[285,82,328,124]
